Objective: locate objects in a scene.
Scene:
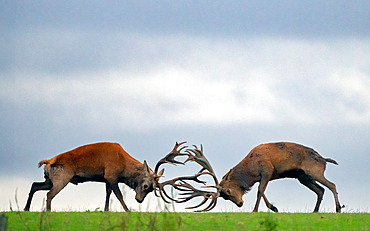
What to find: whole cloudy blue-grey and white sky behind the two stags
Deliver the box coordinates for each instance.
[0,0,370,212]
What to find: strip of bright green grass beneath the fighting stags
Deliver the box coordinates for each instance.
[4,212,370,231]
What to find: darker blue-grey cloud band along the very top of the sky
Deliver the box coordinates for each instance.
[1,1,370,37]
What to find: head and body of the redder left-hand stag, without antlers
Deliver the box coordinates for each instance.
[24,143,154,211]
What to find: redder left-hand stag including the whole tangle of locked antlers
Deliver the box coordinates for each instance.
[24,142,219,211]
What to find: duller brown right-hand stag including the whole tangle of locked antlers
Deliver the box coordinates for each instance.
[139,142,344,212]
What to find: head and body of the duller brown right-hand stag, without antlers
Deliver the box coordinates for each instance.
[220,142,342,213]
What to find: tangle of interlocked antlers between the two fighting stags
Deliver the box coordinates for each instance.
[155,142,221,212]
